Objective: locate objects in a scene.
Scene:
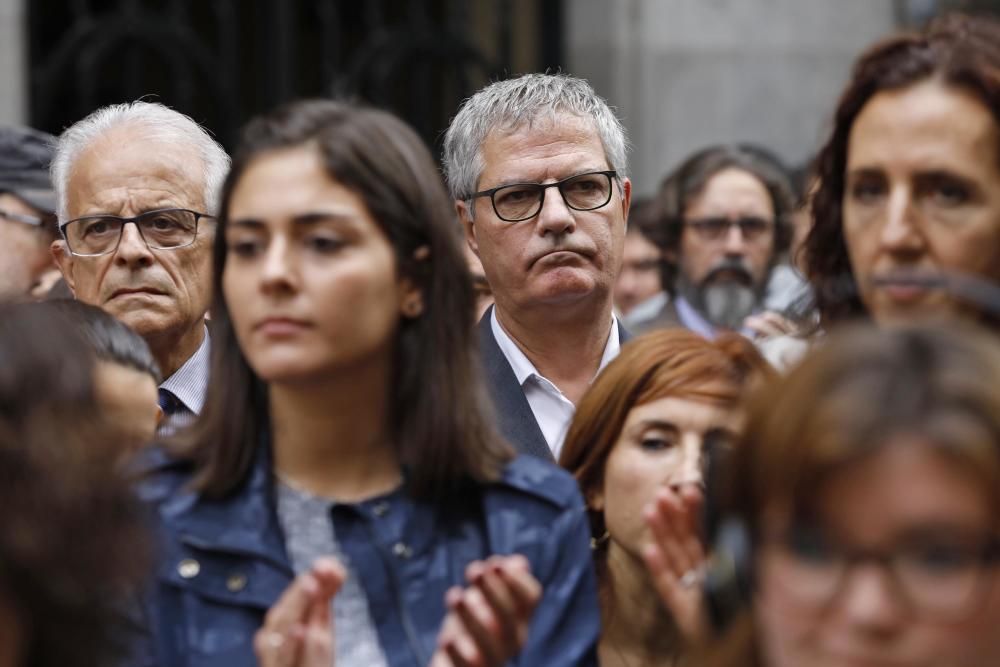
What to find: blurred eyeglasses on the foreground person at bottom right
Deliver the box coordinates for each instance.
[765,528,1000,621]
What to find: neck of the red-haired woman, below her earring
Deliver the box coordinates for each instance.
[601,540,677,666]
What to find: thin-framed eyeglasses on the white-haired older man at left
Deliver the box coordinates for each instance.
[59,208,215,257]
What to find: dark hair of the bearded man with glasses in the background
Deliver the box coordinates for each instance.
[653,144,795,294]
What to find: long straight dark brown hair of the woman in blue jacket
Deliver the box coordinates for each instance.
[175,100,512,500]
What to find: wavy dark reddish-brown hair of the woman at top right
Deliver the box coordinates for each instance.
[803,14,1000,327]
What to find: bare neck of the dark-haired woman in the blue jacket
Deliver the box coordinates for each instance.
[269,354,401,502]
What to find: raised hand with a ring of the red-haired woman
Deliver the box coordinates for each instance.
[643,485,708,643]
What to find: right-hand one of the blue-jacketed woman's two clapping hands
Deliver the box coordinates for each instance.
[430,555,542,667]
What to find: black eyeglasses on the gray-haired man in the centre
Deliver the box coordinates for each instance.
[469,169,618,222]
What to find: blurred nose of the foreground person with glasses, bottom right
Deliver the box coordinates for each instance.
[840,562,905,635]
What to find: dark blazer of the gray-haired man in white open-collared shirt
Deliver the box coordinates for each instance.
[479,306,632,461]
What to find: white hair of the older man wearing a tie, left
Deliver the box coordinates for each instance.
[51,101,230,222]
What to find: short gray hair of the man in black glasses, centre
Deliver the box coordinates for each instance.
[444,73,629,199]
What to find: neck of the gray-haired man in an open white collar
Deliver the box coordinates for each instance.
[496,299,611,403]
